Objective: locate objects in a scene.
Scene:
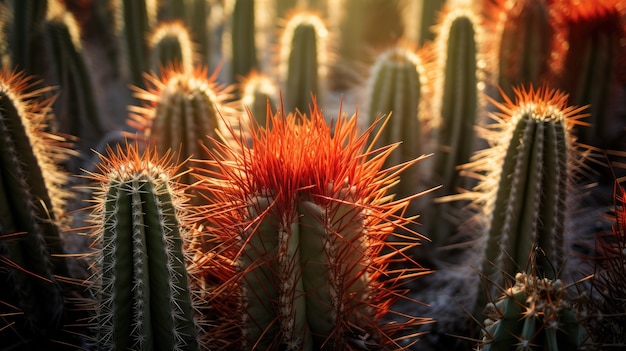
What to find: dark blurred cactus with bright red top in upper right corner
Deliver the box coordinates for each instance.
[552,0,626,151]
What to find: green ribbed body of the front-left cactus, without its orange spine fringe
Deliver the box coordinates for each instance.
[98,175,198,350]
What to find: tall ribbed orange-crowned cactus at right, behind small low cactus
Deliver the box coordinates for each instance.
[464,86,585,320]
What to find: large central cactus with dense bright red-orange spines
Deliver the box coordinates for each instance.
[193,100,426,350]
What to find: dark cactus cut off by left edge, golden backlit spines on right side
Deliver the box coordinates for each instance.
[0,69,69,348]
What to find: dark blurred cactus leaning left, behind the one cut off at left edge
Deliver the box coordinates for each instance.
[44,0,105,162]
